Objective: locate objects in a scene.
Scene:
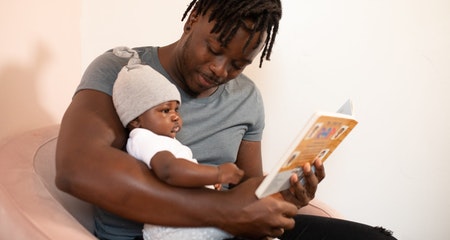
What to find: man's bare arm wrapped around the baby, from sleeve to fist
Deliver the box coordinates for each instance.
[56,90,296,237]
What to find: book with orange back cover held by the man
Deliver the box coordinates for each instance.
[255,100,358,198]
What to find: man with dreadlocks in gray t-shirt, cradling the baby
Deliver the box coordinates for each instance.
[56,0,394,239]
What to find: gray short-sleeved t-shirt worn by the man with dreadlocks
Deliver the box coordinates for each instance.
[77,47,264,239]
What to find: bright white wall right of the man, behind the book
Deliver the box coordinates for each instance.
[251,0,450,240]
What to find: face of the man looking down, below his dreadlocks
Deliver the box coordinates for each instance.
[177,15,265,96]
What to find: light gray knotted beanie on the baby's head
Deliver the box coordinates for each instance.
[112,47,181,127]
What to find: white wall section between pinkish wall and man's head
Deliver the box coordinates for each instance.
[81,0,185,70]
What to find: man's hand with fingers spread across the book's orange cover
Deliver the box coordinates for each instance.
[281,160,325,208]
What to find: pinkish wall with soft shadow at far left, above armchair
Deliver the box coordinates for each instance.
[0,0,81,138]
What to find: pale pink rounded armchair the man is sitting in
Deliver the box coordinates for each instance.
[0,125,340,240]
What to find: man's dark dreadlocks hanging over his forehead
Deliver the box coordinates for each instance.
[181,0,281,67]
